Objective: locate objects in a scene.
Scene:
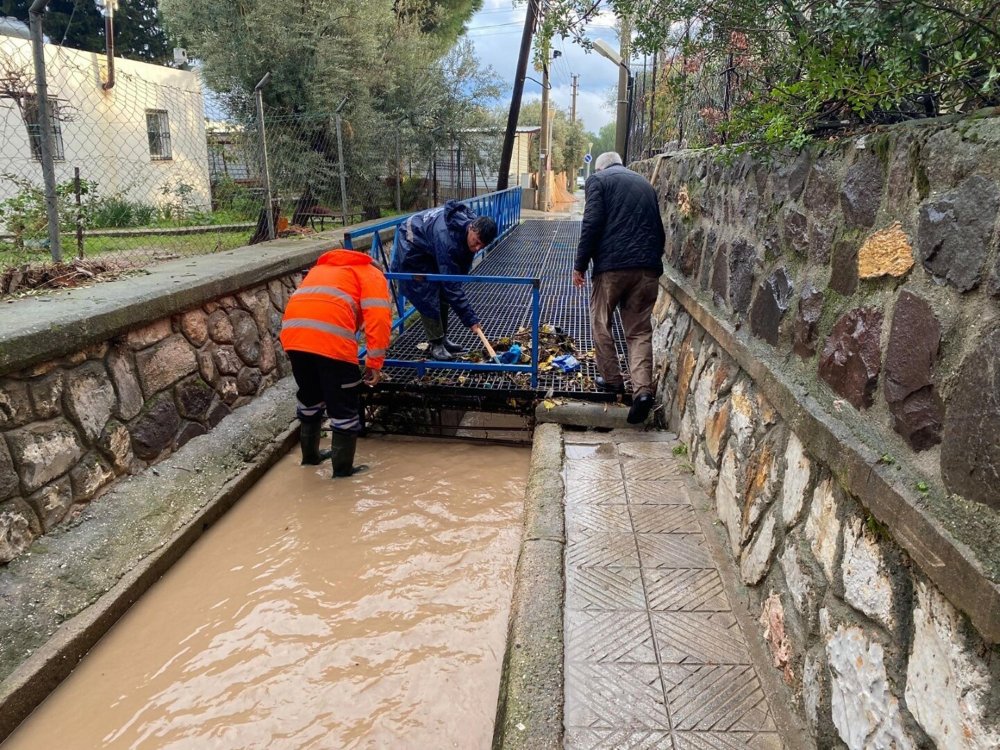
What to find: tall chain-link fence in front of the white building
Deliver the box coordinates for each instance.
[0,22,502,295]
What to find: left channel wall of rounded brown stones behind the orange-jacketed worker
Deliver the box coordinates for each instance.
[0,273,301,563]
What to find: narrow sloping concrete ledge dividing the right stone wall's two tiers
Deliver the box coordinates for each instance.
[661,267,1000,643]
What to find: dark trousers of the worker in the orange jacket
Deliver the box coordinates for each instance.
[288,351,361,435]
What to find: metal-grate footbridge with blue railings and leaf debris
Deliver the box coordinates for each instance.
[345,188,629,424]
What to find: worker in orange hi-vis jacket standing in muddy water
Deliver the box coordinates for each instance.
[281,249,392,477]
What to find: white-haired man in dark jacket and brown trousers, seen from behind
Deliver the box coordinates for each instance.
[573,151,666,424]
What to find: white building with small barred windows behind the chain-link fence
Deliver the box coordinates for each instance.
[0,36,210,223]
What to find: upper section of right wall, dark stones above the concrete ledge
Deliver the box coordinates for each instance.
[643,110,1000,510]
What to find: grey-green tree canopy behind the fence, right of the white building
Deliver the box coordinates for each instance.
[161,0,499,212]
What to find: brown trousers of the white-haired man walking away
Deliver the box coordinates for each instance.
[590,268,659,396]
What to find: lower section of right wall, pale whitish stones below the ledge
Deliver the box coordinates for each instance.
[655,302,1000,750]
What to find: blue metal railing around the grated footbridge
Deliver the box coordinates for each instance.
[344,187,541,389]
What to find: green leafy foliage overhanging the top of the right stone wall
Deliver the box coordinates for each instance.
[542,0,1000,150]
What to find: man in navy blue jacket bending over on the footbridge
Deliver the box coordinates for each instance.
[392,201,497,362]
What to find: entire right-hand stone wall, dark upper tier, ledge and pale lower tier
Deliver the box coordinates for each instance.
[638,111,1000,748]
